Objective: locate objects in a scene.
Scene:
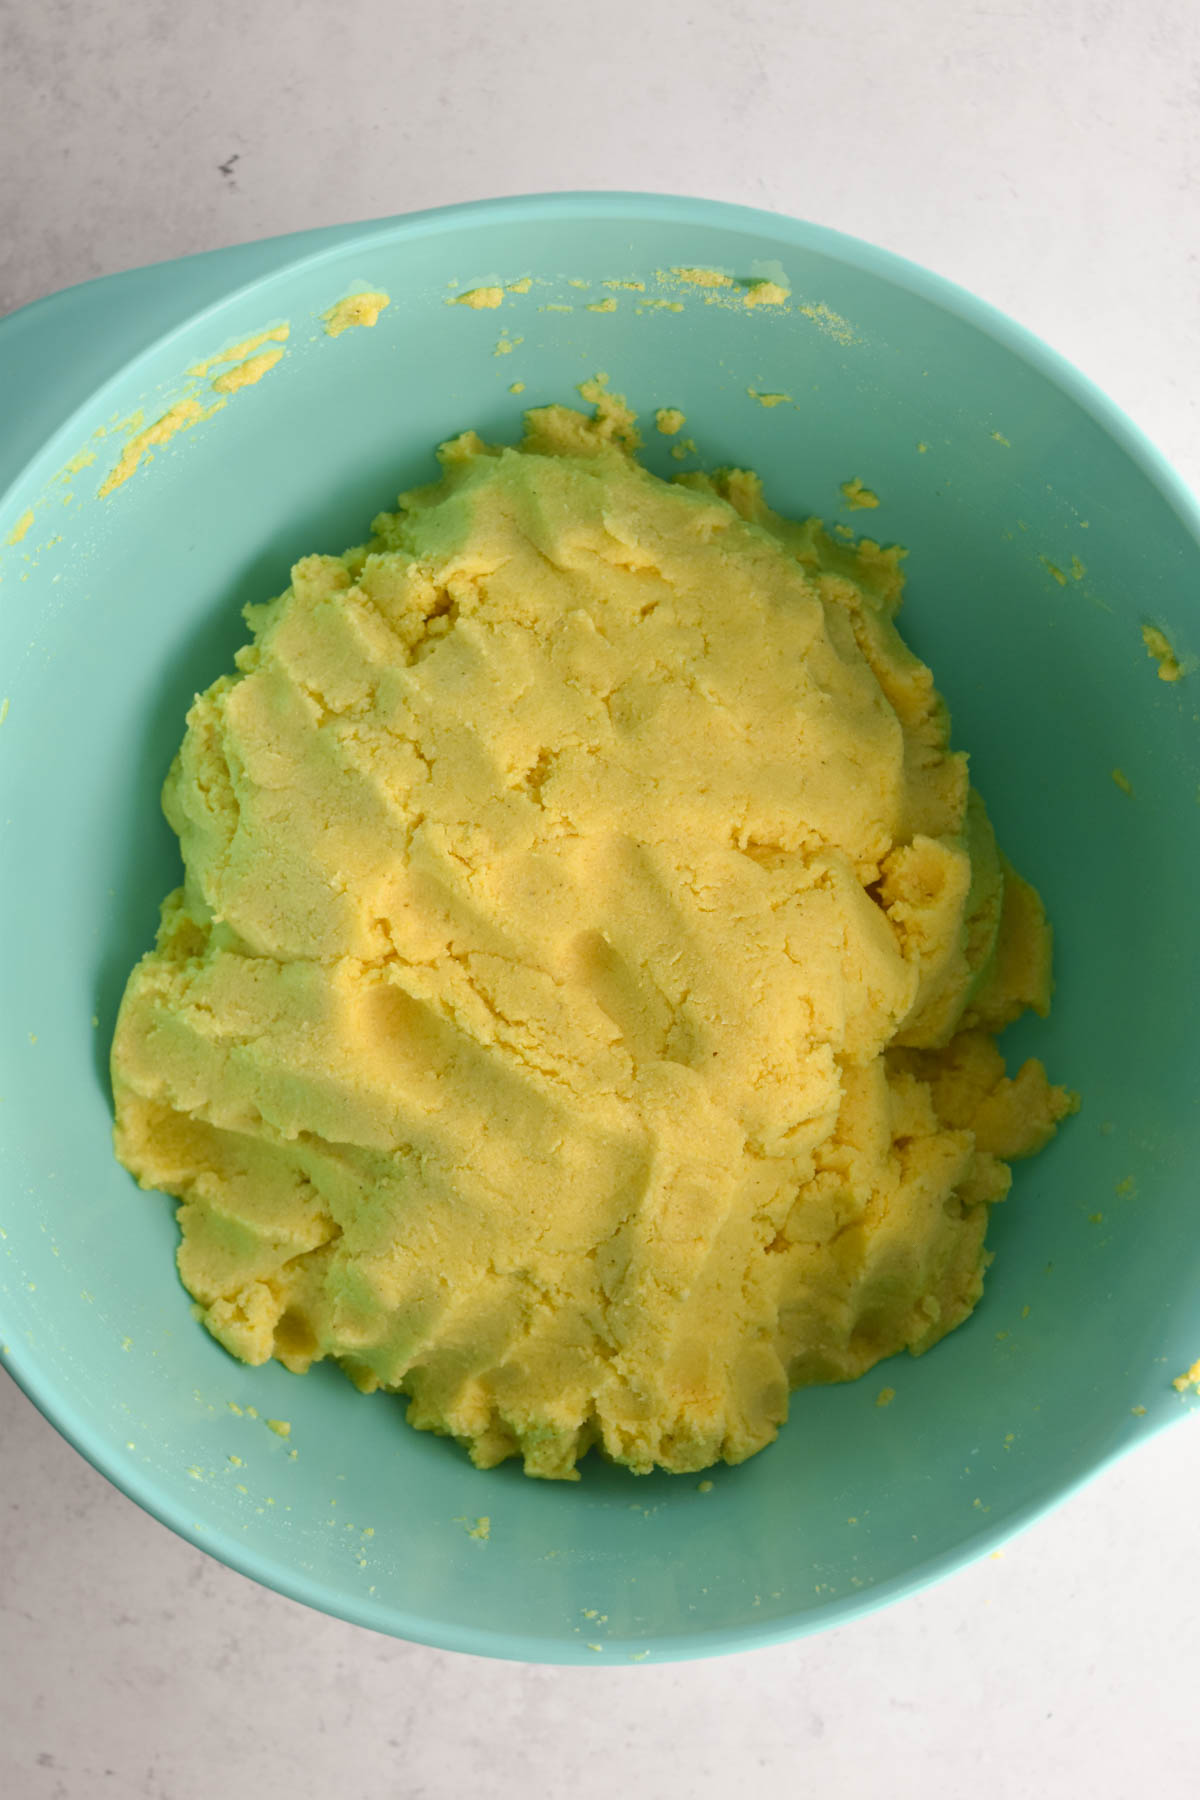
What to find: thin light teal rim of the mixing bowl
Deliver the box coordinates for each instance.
[0,189,1200,1667]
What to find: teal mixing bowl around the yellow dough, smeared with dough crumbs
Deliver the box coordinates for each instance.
[0,194,1200,1665]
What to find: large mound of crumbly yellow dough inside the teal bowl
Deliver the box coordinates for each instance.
[112,383,1072,1476]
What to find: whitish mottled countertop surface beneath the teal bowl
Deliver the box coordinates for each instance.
[0,0,1200,1800]
